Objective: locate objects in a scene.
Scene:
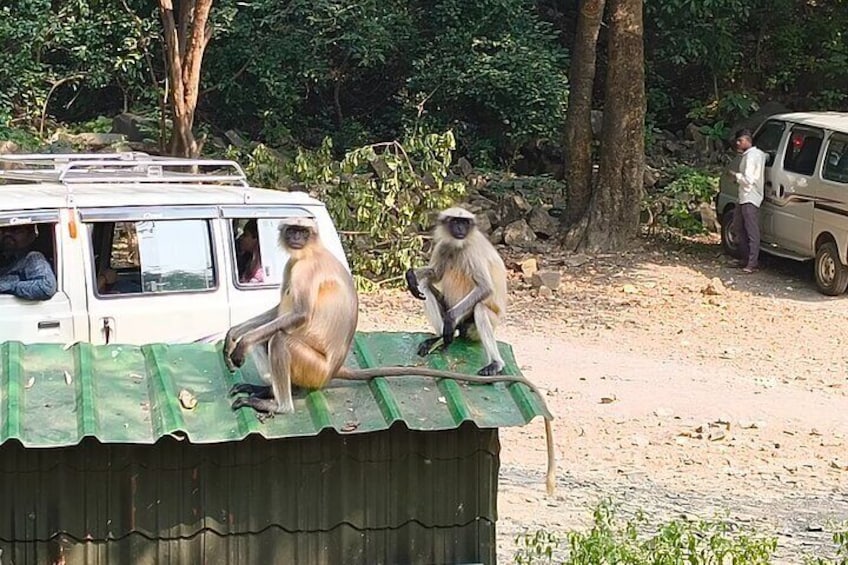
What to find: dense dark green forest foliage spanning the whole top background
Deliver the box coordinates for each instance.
[0,0,848,166]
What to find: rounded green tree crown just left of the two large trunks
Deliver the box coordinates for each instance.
[407,0,568,166]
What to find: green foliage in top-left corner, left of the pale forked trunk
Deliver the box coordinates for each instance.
[0,0,157,128]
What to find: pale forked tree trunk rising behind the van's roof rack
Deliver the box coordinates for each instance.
[159,0,212,157]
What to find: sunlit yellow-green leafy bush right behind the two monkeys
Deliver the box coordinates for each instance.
[228,131,466,290]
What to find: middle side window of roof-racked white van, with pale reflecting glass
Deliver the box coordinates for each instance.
[91,220,217,295]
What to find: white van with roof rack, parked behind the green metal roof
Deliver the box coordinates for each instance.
[0,153,349,344]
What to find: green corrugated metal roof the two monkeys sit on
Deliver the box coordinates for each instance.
[0,332,546,447]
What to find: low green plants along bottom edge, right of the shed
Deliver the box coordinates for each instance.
[506,502,777,565]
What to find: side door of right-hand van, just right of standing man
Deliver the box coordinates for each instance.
[769,124,824,257]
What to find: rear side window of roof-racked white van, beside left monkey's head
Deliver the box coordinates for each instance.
[231,218,288,288]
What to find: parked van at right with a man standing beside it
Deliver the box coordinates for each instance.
[716,112,848,296]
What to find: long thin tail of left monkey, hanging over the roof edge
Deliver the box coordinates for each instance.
[335,366,556,496]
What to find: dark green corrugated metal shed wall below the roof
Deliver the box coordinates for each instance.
[0,423,500,565]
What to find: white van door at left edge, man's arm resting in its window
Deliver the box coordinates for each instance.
[0,210,78,343]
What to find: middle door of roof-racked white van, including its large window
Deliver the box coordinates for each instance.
[80,206,229,344]
